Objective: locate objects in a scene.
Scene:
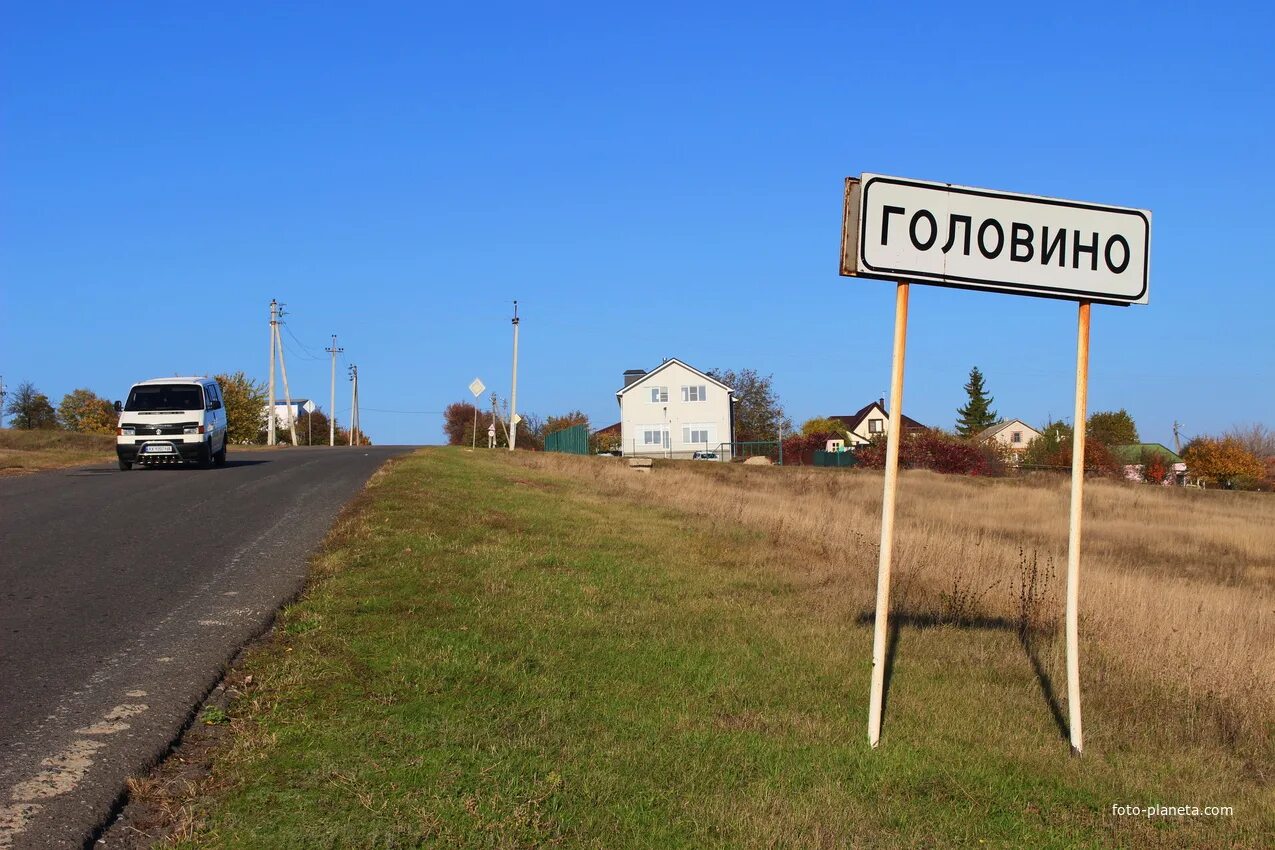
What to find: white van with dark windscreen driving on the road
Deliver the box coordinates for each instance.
[115,377,226,469]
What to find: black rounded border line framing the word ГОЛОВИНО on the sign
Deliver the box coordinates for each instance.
[859,177,1151,307]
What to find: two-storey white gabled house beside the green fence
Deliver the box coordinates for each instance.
[616,358,736,460]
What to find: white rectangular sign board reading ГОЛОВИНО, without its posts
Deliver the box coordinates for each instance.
[842,173,1151,305]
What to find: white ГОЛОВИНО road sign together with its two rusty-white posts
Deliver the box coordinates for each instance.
[842,169,1151,756]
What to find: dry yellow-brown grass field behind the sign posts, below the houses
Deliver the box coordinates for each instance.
[518,454,1275,777]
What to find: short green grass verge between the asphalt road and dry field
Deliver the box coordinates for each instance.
[184,450,1275,849]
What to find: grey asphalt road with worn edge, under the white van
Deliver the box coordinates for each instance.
[0,446,408,850]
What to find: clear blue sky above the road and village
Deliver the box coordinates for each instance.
[0,3,1275,443]
